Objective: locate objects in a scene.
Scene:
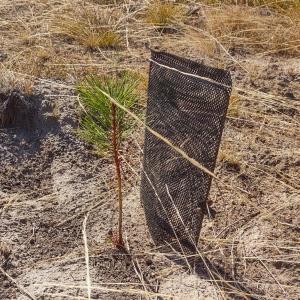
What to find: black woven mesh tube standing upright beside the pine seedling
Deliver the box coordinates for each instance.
[141,51,231,252]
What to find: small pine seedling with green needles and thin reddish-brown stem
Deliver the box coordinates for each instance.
[78,74,139,247]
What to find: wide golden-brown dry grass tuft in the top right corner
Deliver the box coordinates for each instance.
[205,6,300,56]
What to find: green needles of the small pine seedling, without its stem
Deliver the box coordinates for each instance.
[77,73,139,155]
